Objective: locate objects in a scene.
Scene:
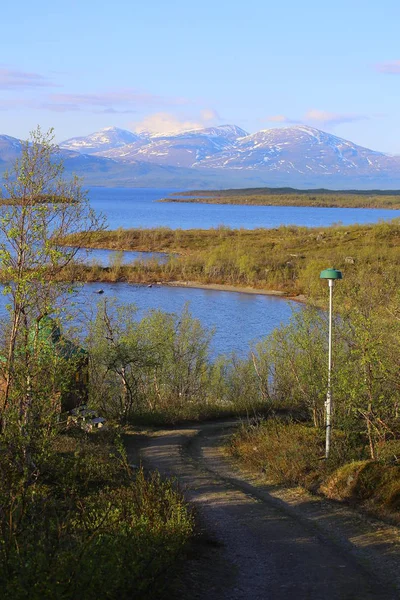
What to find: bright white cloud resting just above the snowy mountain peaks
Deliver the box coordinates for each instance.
[131,109,219,133]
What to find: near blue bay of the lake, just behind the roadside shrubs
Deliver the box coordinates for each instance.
[75,283,301,356]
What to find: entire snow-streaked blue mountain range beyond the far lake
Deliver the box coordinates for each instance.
[0,125,400,189]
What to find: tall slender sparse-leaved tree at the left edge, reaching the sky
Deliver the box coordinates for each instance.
[0,127,104,432]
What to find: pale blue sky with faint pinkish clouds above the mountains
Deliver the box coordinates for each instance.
[0,0,400,154]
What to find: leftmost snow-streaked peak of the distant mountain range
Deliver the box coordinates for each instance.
[60,127,141,154]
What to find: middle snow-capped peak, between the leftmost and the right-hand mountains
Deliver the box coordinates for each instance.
[96,125,248,168]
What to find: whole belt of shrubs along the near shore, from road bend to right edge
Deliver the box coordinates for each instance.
[88,290,400,521]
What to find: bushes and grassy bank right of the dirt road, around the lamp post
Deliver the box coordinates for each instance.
[227,282,400,523]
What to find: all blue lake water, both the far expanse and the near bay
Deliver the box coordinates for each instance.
[0,188,400,356]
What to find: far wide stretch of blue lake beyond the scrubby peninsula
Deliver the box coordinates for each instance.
[89,188,400,229]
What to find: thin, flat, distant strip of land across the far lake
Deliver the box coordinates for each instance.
[160,188,400,209]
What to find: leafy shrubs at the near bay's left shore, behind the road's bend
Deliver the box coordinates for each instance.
[88,303,216,422]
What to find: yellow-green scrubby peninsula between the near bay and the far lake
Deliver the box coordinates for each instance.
[66,219,400,296]
